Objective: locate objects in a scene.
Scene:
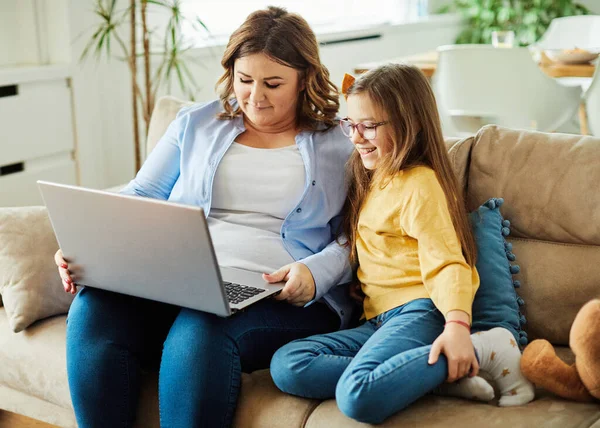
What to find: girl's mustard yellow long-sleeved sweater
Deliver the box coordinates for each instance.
[356,167,479,319]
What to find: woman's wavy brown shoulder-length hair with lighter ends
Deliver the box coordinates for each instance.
[217,6,340,129]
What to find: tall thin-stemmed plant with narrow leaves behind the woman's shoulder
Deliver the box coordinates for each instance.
[81,0,208,171]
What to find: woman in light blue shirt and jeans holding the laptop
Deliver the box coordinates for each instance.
[56,7,352,427]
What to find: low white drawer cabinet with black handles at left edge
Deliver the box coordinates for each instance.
[0,65,78,207]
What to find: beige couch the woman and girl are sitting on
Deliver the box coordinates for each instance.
[0,97,600,428]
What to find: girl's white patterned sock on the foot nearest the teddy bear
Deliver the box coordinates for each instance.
[471,327,535,407]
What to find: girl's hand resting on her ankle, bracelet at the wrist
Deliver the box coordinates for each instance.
[429,311,479,383]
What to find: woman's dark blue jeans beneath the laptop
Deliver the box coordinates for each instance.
[67,288,340,428]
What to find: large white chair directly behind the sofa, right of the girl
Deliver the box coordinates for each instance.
[433,45,581,137]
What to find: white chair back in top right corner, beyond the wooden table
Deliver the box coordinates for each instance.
[531,15,600,52]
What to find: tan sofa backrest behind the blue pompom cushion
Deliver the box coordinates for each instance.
[449,125,600,345]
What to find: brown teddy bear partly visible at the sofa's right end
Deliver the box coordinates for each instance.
[521,299,600,402]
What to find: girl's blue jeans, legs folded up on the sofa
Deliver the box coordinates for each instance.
[271,299,448,424]
